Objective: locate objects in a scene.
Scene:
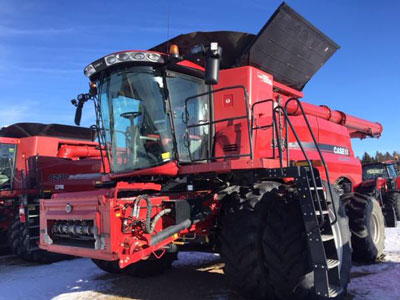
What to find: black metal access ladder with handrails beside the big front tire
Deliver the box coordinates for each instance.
[273,98,343,298]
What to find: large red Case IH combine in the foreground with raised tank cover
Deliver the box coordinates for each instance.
[40,4,383,299]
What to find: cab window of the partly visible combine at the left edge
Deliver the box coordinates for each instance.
[0,144,16,189]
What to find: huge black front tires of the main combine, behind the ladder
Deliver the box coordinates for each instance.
[219,184,351,299]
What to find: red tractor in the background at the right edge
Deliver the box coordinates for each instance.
[360,161,400,227]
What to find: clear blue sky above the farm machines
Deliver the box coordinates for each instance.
[0,0,400,155]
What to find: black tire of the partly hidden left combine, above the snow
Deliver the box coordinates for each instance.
[9,216,71,264]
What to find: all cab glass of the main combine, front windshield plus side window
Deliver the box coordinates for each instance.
[99,67,209,173]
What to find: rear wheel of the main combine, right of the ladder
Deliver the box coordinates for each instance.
[342,193,385,263]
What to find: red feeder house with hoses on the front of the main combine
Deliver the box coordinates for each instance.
[40,190,213,267]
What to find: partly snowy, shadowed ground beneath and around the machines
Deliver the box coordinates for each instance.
[0,224,400,300]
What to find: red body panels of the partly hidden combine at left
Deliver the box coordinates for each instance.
[0,127,102,234]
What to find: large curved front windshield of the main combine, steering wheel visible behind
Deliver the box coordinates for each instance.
[99,68,174,173]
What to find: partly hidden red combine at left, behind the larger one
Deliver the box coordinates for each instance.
[0,123,101,262]
